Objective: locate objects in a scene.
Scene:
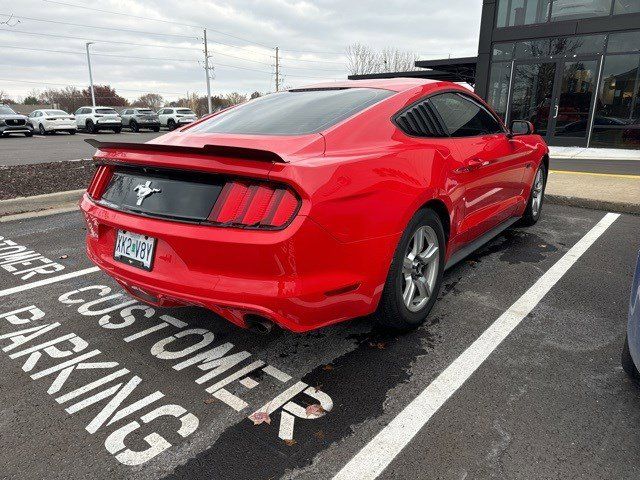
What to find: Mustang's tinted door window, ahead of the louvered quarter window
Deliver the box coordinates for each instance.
[430,93,504,137]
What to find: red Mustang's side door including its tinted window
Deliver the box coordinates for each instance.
[430,92,525,242]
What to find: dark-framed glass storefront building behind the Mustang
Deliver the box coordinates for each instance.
[475,0,640,149]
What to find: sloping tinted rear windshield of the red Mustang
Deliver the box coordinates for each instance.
[191,88,394,135]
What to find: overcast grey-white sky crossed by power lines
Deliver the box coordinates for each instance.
[0,0,482,99]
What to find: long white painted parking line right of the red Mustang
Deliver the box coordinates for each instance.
[333,213,620,480]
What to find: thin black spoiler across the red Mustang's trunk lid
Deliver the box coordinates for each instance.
[85,138,288,163]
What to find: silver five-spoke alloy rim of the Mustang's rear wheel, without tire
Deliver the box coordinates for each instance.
[402,225,440,313]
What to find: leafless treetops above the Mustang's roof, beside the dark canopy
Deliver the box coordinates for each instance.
[346,43,418,75]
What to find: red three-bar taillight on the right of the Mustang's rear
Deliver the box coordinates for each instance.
[209,181,300,229]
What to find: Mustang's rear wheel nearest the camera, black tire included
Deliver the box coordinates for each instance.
[375,209,446,331]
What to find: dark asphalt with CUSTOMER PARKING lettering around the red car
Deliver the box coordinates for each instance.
[0,205,640,479]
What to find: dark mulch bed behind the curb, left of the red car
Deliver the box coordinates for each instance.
[0,160,95,200]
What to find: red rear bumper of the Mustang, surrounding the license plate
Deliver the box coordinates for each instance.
[80,195,397,332]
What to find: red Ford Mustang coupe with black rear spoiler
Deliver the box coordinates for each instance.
[81,78,549,332]
